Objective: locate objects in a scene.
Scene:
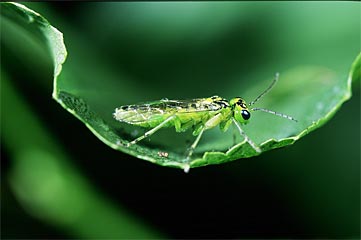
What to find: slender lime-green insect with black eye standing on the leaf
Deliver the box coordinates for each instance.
[113,73,297,161]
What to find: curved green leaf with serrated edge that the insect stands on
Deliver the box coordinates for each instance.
[7,1,360,172]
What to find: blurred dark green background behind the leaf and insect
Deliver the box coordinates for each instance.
[1,2,361,239]
